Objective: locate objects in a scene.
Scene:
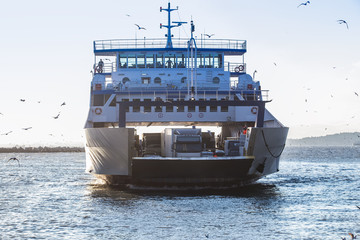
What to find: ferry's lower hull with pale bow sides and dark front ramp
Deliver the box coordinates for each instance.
[85,128,288,187]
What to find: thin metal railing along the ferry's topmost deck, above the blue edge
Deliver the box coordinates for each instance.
[94,38,246,51]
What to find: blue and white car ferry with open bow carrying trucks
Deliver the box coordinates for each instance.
[85,3,289,187]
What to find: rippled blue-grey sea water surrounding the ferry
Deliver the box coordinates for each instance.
[0,147,360,239]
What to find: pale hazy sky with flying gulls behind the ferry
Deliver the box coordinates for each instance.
[0,0,360,146]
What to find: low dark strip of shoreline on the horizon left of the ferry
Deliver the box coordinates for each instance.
[0,147,85,153]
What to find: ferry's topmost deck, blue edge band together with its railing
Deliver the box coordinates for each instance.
[94,38,246,56]
